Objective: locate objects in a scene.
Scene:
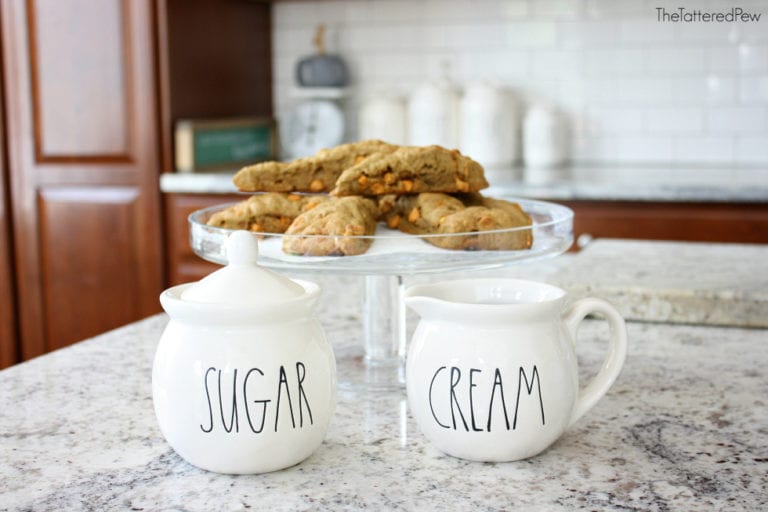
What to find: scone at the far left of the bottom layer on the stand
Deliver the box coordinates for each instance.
[207,192,329,233]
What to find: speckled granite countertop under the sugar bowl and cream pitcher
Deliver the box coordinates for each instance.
[0,242,768,511]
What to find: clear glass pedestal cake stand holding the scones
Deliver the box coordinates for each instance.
[189,196,573,391]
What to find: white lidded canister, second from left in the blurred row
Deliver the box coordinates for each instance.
[408,82,459,149]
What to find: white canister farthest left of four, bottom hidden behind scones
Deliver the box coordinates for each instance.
[359,94,408,145]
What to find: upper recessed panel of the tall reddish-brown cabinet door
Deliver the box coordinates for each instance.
[28,0,131,161]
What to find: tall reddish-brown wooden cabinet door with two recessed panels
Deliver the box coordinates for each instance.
[0,0,163,359]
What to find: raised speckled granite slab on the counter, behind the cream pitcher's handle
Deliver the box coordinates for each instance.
[476,239,768,327]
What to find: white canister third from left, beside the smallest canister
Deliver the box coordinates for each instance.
[459,82,520,168]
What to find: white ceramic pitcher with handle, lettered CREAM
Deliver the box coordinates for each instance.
[405,279,627,462]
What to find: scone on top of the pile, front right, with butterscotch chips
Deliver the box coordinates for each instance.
[331,146,488,196]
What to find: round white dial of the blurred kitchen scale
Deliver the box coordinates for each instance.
[281,100,344,158]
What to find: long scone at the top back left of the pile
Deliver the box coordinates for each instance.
[232,140,397,192]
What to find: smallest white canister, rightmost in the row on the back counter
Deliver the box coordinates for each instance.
[523,104,569,172]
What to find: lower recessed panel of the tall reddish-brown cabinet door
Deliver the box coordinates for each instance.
[39,187,142,349]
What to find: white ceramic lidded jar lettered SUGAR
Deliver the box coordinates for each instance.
[152,231,336,474]
